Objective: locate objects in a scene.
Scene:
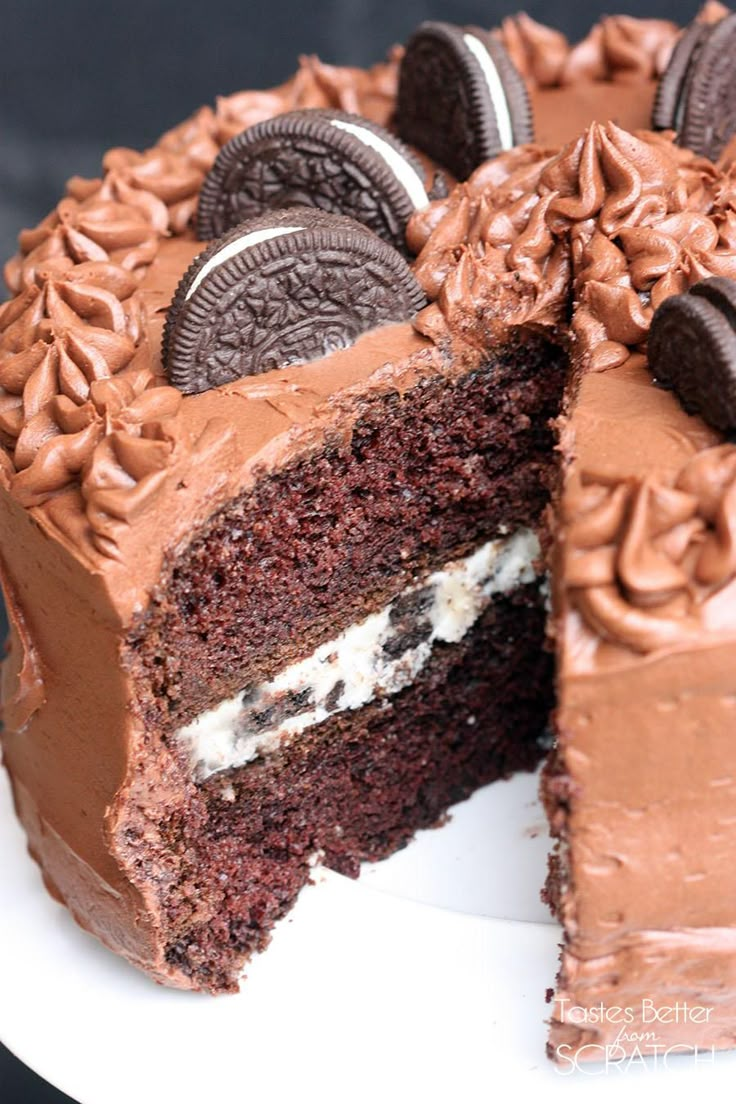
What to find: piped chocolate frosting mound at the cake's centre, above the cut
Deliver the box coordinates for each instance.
[408,123,736,370]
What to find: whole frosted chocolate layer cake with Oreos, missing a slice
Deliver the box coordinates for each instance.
[0,4,736,1061]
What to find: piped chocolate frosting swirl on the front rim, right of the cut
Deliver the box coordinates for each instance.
[565,445,736,654]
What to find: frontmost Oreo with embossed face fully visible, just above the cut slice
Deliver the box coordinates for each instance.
[162,208,426,394]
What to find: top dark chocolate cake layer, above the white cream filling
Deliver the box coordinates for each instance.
[126,331,565,725]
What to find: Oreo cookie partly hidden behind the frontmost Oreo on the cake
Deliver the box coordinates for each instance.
[198,108,441,252]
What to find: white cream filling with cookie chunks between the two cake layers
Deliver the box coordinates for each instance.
[174,529,540,782]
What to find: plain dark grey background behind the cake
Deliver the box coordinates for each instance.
[0,0,697,1104]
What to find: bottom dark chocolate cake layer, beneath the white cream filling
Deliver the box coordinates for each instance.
[147,584,552,991]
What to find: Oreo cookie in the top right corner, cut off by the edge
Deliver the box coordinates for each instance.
[652,14,736,161]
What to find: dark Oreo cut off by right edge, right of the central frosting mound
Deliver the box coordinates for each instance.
[649,276,736,433]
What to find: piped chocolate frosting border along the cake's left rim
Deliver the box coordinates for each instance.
[0,50,401,556]
